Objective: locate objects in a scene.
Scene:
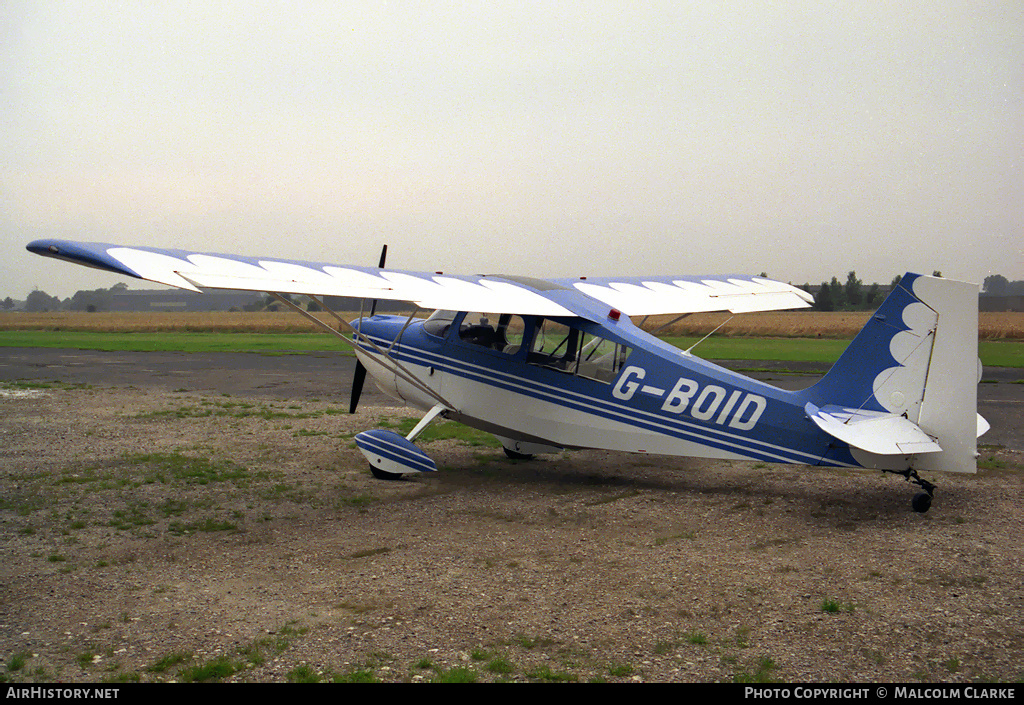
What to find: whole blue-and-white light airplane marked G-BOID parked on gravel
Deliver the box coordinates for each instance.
[28,240,988,511]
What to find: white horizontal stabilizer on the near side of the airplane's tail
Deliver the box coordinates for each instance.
[804,403,942,455]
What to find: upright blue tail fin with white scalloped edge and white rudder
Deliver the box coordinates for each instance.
[807,274,979,472]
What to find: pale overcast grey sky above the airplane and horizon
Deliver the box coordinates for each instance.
[0,0,1024,298]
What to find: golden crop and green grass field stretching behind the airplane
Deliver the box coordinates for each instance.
[0,312,1024,367]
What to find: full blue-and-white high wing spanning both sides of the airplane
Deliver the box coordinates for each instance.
[28,240,813,316]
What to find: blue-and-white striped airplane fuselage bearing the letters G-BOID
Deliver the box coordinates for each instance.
[352,314,857,465]
